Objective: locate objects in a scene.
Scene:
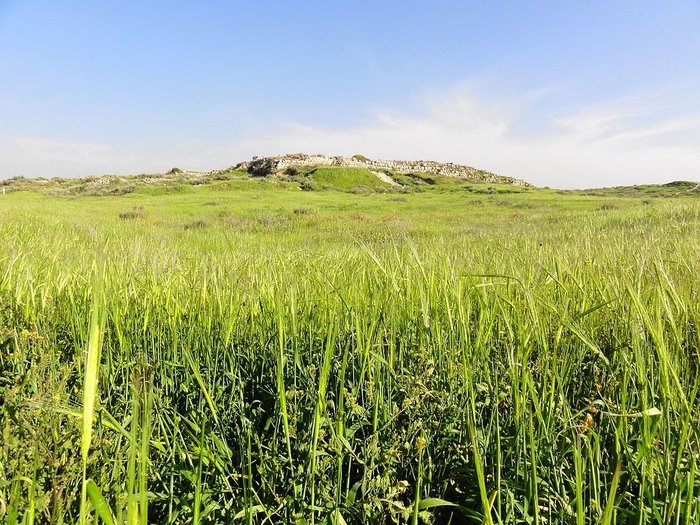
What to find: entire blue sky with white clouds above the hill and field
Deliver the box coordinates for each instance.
[0,0,700,188]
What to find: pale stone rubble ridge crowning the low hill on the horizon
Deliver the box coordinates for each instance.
[236,153,530,186]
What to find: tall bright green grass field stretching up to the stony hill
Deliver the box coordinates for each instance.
[0,174,700,525]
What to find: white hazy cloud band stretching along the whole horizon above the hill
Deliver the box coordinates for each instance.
[0,86,700,188]
